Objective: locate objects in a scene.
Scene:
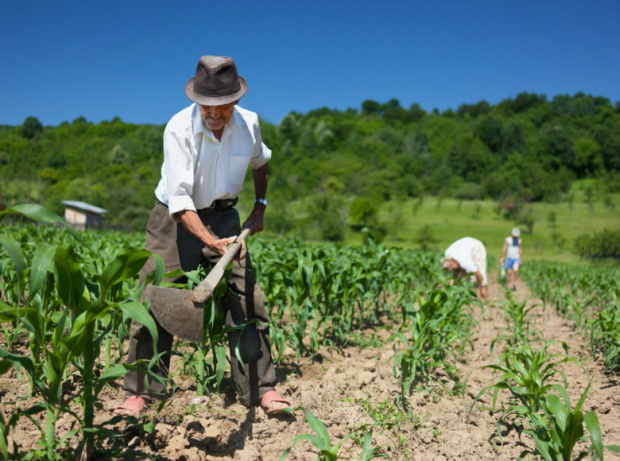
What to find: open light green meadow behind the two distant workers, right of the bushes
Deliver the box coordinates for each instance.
[379,197,620,263]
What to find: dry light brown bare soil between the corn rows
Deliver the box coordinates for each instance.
[0,274,620,461]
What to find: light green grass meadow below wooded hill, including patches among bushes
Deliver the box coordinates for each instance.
[238,181,620,263]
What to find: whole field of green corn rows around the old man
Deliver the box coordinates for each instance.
[0,205,620,460]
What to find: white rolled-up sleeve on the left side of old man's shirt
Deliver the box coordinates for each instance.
[163,128,196,216]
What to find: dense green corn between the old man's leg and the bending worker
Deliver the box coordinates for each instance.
[251,240,444,357]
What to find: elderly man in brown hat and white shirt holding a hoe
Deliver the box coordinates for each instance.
[115,56,291,415]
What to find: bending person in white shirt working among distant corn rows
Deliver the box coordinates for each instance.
[441,237,487,299]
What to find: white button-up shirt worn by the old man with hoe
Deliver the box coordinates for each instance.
[155,104,271,216]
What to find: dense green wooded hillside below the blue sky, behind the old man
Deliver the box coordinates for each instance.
[0,93,620,230]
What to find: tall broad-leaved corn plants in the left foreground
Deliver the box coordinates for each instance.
[0,206,162,459]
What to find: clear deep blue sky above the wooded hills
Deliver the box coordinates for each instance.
[0,0,620,125]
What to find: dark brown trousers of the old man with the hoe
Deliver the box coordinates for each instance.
[125,203,276,406]
